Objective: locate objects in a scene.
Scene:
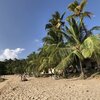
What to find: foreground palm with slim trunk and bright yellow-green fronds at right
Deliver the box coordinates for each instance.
[57,18,100,76]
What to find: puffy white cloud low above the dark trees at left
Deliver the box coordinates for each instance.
[0,48,25,61]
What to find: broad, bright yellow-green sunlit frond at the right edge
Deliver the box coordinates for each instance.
[81,35,100,58]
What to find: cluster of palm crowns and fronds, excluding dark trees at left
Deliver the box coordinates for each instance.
[28,0,100,77]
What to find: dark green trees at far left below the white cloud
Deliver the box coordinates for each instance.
[0,59,27,75]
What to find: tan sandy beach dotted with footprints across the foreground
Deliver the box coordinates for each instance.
[0,75,100,100]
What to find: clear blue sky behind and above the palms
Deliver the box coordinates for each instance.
[0,0,100,58]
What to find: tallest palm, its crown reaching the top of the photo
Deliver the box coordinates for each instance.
[67,0,93,38]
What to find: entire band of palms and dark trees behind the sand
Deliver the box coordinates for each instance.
[0,0,100,77]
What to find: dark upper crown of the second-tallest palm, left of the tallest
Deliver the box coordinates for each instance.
[43,12,65,44]
